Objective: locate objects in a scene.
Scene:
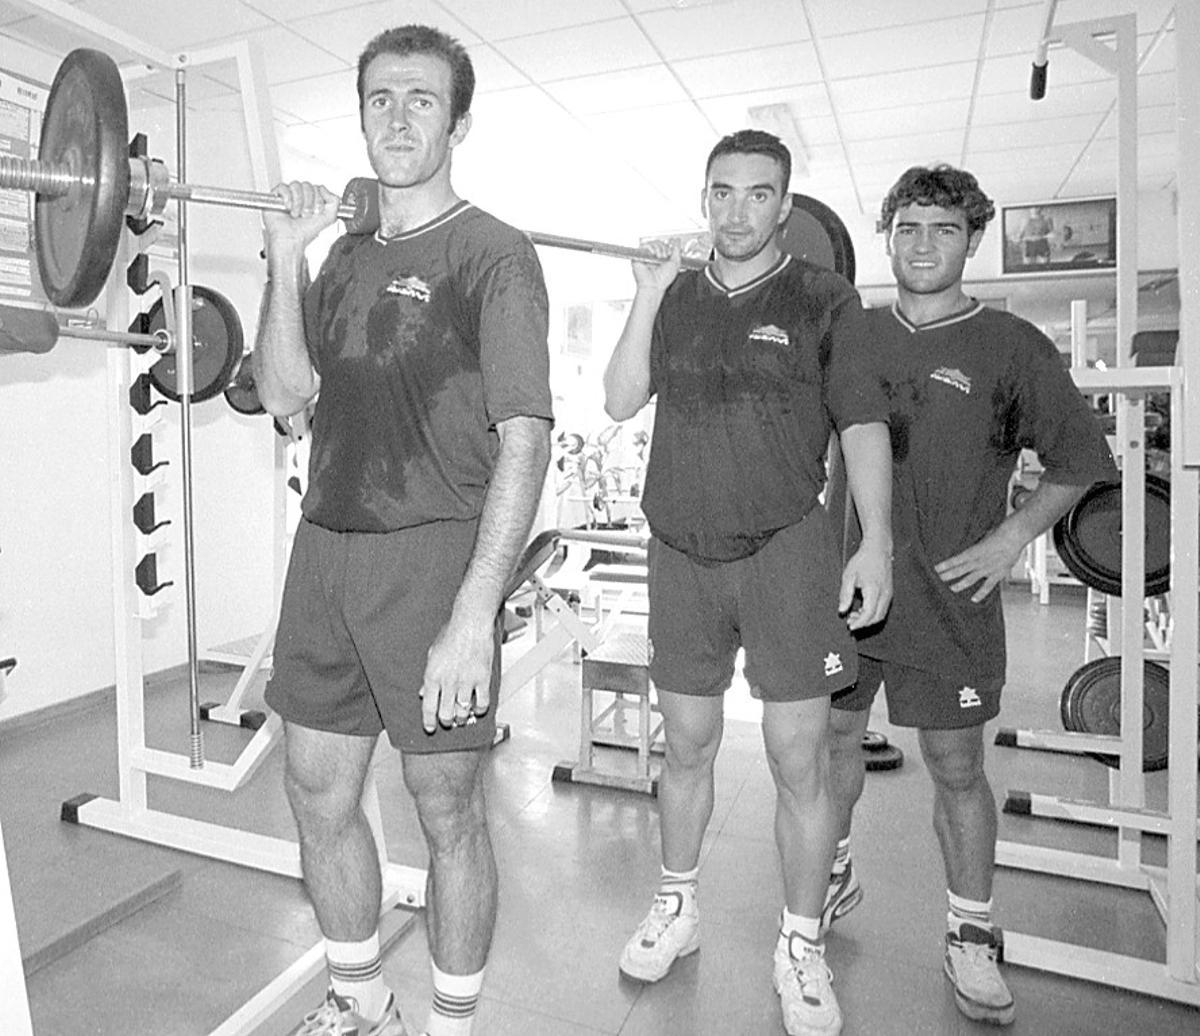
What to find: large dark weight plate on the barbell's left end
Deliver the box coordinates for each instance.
[34,48,130,309]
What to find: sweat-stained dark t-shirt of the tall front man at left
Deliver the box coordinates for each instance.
[302,202,552,532]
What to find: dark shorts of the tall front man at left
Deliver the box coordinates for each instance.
[265,520,500,753]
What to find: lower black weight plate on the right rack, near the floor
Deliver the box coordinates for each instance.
[1058,655,1170,772]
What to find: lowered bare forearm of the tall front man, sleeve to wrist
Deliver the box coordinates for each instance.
[455,418,550,616]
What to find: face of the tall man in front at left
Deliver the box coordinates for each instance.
[362,54,470,187]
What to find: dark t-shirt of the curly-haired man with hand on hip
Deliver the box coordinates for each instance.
[859,303,1116,683]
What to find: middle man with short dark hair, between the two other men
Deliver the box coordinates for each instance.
[605,130,890,1034]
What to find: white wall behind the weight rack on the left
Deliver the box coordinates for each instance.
[0,40,277,720]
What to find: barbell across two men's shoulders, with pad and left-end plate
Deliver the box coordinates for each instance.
[0,48,704,309]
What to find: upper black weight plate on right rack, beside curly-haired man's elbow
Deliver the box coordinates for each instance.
[1054,473,1171,597]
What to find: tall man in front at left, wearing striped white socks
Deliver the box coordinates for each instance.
[254,25,551,1036]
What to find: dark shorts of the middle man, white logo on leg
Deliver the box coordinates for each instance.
[647,507,858,701]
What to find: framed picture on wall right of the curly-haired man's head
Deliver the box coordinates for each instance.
[1000,198,1117,274]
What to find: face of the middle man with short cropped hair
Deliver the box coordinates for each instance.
[700,154,792,261]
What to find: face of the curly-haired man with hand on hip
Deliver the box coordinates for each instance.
[887,205,983,295]
